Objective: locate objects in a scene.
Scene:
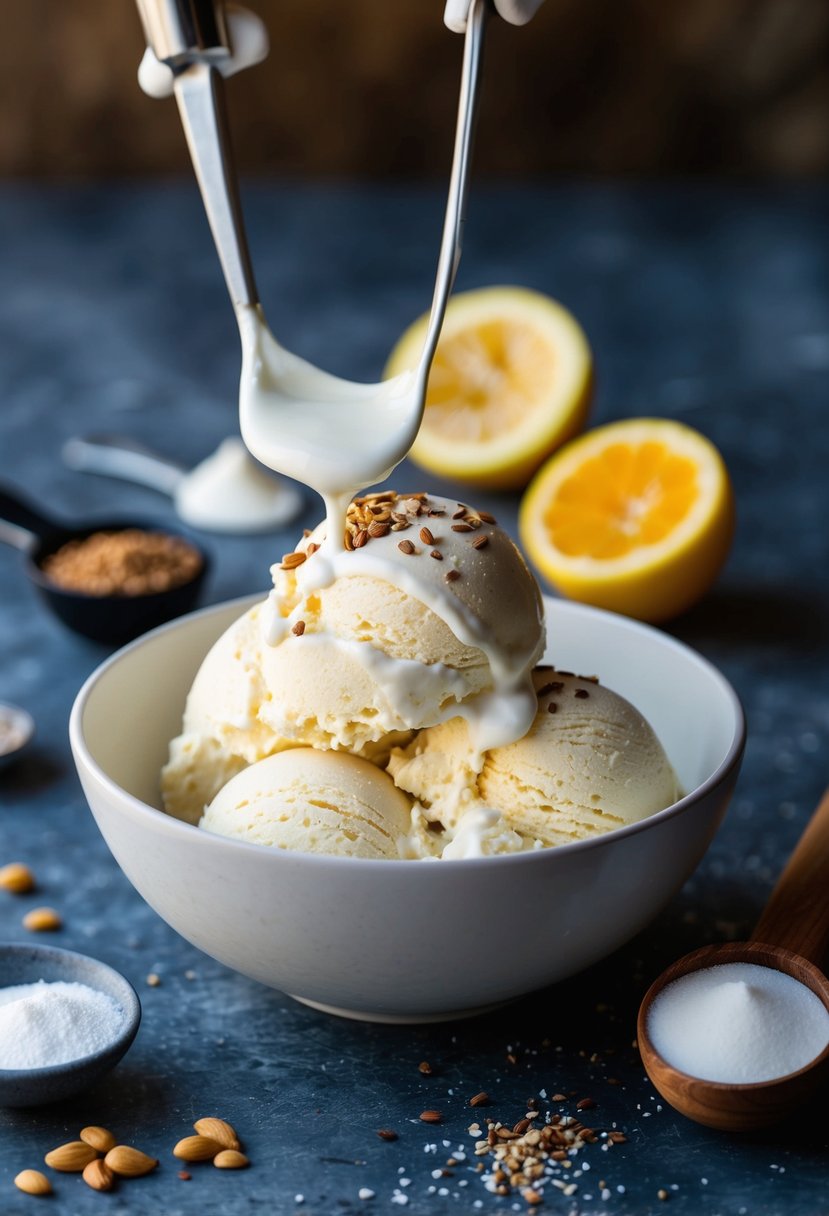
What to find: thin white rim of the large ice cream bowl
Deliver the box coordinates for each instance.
[69,593,746,876]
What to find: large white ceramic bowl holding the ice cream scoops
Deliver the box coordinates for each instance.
[69,599,745,1021]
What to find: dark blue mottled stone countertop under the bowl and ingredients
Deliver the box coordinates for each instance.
[0,182,829,1216]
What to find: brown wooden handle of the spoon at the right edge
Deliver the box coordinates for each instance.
[751,789,829,967]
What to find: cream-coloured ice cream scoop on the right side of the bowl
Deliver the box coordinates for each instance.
[389,668,678,856]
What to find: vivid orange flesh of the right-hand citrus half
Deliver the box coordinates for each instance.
[543,440,699,561]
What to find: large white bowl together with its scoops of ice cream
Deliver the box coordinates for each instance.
[71,491,744,1020]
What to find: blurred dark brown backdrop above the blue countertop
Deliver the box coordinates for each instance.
[0,0,829,178]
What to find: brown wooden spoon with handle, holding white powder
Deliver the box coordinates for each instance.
[637,790,829,1131]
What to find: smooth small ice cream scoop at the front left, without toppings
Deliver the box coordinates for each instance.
[201,748,411,857]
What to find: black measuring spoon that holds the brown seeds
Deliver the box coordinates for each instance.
[0,488,209,646]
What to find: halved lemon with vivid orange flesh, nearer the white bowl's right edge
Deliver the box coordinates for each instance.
[519,418,734,621]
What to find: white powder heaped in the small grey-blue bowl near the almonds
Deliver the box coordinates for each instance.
[0,980,124,1069]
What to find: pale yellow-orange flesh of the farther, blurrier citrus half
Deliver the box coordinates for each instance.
[425,320,557,443]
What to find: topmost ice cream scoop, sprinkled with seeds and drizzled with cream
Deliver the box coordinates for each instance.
[260,494,545,751]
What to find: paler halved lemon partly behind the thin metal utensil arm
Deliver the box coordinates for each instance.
[385,287,592,489]
